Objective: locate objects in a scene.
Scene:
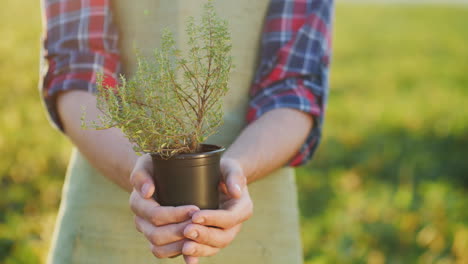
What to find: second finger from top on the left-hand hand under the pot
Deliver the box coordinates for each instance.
[135,216,192,246]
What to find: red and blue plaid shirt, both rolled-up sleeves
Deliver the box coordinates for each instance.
[41,0,333,166]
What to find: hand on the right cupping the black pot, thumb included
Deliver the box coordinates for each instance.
[182,158,253,264]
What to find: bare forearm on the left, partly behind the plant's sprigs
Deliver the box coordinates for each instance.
[57,90,137,191]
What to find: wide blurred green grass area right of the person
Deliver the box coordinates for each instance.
[298,5,468,263]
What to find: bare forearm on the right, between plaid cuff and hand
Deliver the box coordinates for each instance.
[224,108,313,183]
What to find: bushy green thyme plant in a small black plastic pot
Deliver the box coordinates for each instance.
[82,1,232,209]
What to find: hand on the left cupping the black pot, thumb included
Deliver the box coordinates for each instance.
[130,155,200,262]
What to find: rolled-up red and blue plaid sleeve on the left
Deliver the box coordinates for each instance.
[39,0,120,130]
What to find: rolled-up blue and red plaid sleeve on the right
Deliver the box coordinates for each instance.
[247,0,333,166]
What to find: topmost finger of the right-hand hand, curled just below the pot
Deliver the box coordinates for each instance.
[192,195,253,229]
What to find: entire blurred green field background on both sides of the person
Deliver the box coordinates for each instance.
[0,0,468,264]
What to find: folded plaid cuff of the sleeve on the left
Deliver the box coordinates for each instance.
[40,52,120,132]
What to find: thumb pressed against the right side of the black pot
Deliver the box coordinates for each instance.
[221,159,247,198]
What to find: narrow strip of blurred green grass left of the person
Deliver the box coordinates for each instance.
[0,0,71,264]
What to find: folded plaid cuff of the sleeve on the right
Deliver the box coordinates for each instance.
[247,77,324,167]
